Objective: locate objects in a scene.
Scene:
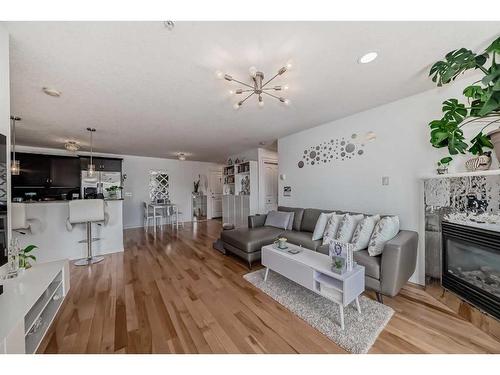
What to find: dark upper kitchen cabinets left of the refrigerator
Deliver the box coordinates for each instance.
[12,153,80,188]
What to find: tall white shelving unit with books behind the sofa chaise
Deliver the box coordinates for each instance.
[222,161,259,228]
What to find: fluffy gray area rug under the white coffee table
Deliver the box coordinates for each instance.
[243,269,394,353]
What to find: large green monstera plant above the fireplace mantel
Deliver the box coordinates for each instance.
[429,37,500,165]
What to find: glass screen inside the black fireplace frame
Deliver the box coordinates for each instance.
[445,238,500,298]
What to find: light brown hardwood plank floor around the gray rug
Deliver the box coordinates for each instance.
[39,221,500,353]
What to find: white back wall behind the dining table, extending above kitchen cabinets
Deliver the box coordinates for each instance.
[17,146,222,228]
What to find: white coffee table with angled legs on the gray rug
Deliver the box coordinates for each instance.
[261,244,365,329]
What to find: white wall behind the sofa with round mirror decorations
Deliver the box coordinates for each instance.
[278,74,486,284]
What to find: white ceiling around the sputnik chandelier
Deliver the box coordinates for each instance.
[7,22,499,161]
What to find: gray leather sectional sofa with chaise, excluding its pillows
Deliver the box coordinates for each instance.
[221,206,418,301]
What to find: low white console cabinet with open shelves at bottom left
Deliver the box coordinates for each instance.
[0,260,70,354]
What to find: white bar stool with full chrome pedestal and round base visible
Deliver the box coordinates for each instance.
[66,199,109,266]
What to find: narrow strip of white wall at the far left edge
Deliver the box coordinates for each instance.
[0,22,11,270]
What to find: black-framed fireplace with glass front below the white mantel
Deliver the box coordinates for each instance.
[441,221,500,319]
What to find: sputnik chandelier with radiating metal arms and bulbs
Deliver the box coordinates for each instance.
[216,62,292,109]
